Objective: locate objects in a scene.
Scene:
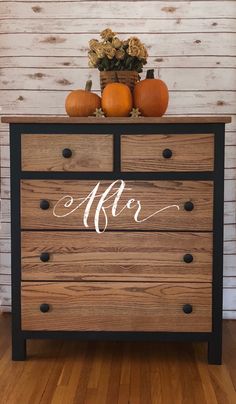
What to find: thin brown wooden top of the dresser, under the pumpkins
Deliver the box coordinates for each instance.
[1,115,231,124]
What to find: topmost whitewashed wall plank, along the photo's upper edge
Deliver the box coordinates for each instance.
[0,0,236,20]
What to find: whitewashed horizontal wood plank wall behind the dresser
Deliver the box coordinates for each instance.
[0,0,236,318]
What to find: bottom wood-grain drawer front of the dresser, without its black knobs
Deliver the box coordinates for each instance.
[21,282,211,332]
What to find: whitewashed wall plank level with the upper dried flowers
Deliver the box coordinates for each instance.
[1,32,236,57]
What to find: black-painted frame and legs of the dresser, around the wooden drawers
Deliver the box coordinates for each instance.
[10,123,225,364]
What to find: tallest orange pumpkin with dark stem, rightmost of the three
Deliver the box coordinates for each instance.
[133,70,169,116]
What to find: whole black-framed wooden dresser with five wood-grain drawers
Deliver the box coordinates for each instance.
[2,116,230,364]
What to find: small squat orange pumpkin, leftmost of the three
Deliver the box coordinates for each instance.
[65,80,101,117]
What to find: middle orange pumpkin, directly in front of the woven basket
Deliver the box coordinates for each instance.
[102,83,133,116]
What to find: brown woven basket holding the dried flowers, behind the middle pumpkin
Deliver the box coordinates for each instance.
[100,70,139,92]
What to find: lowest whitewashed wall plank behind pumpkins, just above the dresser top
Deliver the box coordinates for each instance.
[1,89,236,114]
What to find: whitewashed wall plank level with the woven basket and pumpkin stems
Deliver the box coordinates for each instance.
[1,67,236,92]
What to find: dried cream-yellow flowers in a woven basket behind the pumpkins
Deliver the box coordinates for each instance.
[88,28,148,91]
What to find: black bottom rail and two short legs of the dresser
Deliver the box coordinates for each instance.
[12,331,221,365]
